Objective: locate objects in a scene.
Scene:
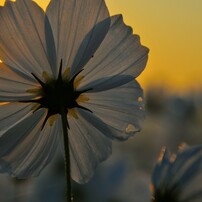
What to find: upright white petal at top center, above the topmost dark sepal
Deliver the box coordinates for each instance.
[47,0,110,75]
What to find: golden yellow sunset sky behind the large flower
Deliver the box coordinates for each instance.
[0,0,202,92]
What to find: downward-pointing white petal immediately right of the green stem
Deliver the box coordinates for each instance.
[68,110,111,183]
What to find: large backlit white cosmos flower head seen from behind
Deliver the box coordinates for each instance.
[0,0,148,183]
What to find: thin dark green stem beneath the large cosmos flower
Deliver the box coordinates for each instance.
[60,108,73,202]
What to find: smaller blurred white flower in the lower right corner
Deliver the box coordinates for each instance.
[151,145,202,202]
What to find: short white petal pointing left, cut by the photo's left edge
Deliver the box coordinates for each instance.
[0,63,39,102]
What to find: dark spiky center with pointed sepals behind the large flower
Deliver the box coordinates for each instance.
[22,61,91,127]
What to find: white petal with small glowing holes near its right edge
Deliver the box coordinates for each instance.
[79,81,145,140]
